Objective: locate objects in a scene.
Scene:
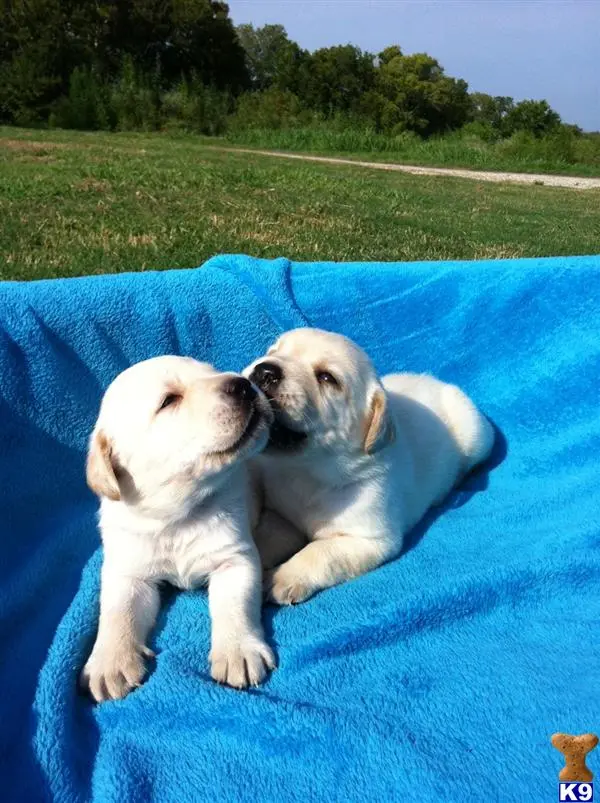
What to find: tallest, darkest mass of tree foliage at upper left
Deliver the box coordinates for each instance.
[0,0,249,122]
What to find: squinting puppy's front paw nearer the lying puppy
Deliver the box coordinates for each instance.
[209,636,275,689]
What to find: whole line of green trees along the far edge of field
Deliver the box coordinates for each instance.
[0,0,580,140]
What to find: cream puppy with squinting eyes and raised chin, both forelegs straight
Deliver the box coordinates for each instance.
[81,356,275,701]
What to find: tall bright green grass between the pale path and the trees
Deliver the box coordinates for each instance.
[227,125,600,176]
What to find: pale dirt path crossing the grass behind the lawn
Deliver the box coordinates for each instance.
[211,147,600,190]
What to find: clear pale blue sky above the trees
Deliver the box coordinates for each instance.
[228,0,600,130]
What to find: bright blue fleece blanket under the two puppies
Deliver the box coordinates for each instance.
[0,257,600,803]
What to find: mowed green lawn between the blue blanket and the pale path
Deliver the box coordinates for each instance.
[0,128,600,279]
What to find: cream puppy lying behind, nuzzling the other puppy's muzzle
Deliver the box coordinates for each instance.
[244,329,494,605]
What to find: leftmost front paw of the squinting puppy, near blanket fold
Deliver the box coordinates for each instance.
[80,644,154,703]
